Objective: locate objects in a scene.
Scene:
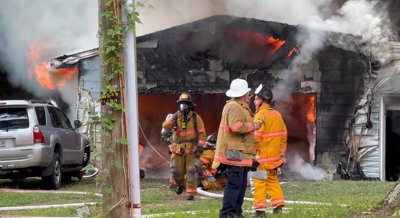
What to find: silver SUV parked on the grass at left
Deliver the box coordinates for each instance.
[0,100,93,189]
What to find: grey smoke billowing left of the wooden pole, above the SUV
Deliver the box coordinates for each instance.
[0,0,98,117]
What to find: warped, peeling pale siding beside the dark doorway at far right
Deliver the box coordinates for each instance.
[349,42,400,180]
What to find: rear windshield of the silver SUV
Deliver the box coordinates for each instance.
[0,108,29,129]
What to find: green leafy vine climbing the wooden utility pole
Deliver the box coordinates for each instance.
[94,0,153,217]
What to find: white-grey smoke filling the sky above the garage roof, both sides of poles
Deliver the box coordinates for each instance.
[0,0,392,94]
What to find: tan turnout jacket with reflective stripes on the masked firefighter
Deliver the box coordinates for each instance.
[162,111,207,153]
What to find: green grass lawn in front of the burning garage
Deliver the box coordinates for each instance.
[0,179,394,218]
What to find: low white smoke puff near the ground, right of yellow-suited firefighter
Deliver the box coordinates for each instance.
[288,155,326,180]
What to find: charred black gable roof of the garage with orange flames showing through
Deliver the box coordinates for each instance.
[51,15,362,69]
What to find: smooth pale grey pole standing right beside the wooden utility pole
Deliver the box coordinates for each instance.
[121,0,141,218]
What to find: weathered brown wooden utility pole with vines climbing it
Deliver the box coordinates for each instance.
[98,0,130,218]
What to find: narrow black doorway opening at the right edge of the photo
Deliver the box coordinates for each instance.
[385,110,400,181]
